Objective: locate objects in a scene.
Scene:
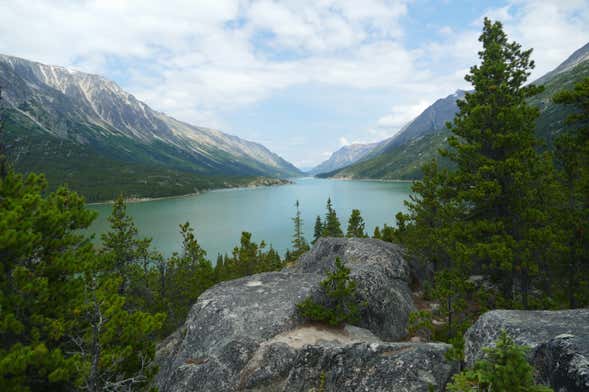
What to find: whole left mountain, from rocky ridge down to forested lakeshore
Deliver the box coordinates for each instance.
[0,55,301,199]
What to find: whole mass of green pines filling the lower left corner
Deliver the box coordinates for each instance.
[0,171,164,391]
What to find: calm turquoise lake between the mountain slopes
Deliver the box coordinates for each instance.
[89,178,411,262]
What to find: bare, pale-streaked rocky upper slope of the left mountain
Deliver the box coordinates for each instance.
[0,55,300,176]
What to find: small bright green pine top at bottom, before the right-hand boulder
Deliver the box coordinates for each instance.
[447,331,552,392]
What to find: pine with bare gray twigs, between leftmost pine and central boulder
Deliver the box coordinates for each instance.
[72,258,166,392]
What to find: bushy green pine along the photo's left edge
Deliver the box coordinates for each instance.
[0,170,95,391]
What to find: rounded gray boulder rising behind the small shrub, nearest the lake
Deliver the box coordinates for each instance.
[288,238,415,341]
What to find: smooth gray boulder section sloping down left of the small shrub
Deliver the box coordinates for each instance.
[157,272,321,392]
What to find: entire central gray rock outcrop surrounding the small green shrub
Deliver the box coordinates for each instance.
[157,239,456,392]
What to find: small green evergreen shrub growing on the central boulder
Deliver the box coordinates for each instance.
[297,257,362,326]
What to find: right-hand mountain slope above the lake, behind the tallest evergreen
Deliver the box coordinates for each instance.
[317,43,589,180]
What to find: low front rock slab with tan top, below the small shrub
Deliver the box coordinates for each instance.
[239,327,458,392]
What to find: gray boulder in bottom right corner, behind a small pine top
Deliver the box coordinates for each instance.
[465,309,589,392]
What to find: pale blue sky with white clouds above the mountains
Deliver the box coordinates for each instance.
[0,0,589,168]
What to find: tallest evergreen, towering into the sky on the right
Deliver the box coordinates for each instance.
[397,19,560,324]
